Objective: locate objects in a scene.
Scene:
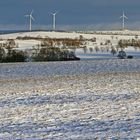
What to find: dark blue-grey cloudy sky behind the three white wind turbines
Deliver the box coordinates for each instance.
[0,0,140,30]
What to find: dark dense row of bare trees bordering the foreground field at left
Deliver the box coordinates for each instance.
[0,46,80,63]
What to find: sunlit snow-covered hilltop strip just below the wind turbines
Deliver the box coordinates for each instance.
[0,31,140,39]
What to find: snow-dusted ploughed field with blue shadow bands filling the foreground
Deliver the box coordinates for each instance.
[0,59,140,140]
